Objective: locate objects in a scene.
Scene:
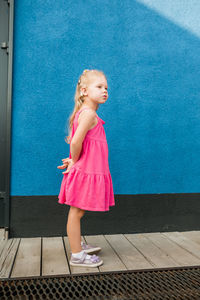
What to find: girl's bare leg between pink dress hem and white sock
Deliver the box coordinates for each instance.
[67,206,85,253]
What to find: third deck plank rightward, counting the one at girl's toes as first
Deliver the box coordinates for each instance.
[125,234,178,268]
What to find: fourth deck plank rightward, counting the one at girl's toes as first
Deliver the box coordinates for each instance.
[145,232,198,266]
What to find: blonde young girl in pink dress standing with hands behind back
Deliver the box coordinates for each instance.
[58,70,115,267]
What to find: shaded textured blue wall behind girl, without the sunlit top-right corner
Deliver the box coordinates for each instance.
[11,0,200,195]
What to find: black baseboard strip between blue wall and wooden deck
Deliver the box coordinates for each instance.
[9,193,200,238]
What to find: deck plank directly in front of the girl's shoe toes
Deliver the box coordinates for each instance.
[84,235,127,272]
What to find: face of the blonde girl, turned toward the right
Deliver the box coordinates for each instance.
[86,75,108,104]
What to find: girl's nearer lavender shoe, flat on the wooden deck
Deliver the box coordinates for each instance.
[69,252,103,268]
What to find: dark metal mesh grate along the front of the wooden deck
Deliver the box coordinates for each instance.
[0,266,200,300]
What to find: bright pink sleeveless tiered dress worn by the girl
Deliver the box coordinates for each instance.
[58,107,115,211]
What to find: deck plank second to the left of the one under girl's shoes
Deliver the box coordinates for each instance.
[11,238,41,278]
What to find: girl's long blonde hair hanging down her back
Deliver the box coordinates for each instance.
[65,69,106,144]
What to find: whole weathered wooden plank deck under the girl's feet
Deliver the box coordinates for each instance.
[0,231,200,278]
